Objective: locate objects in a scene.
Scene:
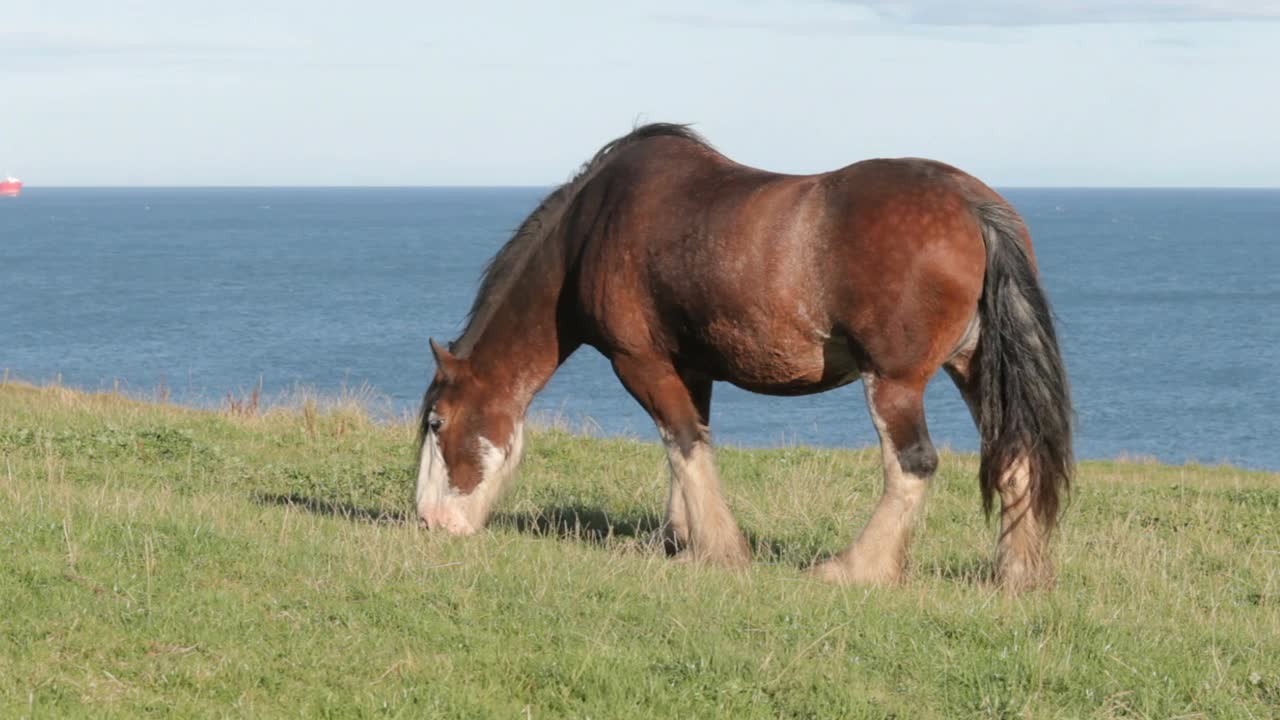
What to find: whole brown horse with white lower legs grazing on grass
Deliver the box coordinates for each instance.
[417,124,1073,588]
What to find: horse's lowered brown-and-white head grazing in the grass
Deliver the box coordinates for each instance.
[417,341,524,534]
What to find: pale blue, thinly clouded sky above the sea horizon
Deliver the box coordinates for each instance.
[0,0,1280,187]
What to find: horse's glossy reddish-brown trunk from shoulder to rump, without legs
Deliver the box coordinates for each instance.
[580,138,986,393]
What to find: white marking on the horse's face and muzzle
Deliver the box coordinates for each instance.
[417,423,525,536]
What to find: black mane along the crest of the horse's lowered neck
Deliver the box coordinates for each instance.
[451,123,710,356]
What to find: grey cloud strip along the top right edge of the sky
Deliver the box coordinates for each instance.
[832,0,1280,26]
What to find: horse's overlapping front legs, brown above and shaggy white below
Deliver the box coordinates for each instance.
[613,357,751,566]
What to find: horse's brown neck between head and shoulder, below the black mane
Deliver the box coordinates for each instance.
[470,271,580,411]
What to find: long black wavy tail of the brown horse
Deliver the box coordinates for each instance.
[973,202,1074,532]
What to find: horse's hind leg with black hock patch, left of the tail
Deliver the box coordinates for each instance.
[813,374,938,584]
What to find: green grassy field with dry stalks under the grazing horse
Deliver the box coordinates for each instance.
[0,382,1280,719]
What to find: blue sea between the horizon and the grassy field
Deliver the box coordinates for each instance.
[0,188,1280,469]
